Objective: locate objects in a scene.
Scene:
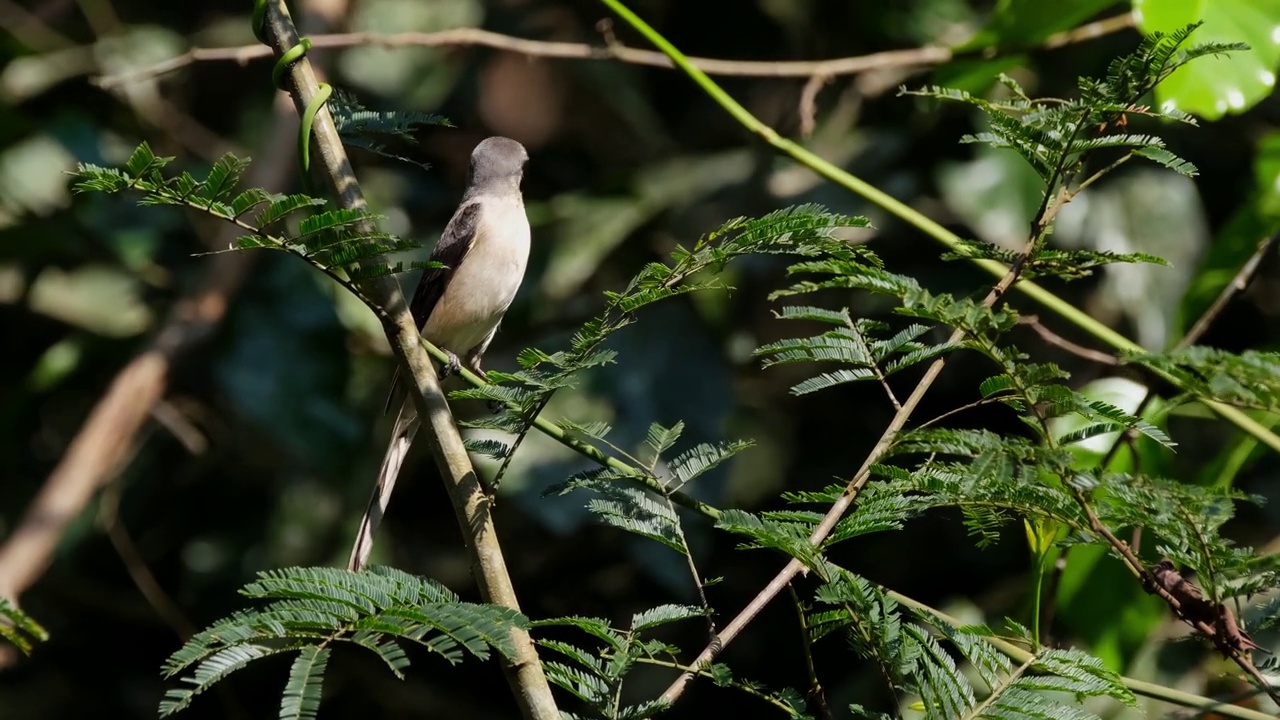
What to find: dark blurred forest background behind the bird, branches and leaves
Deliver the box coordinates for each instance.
[0,0,1280,720]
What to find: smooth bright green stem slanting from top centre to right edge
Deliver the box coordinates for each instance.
[600,0,1280,452]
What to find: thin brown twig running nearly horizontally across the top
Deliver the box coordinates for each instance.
[93,13,1133,87]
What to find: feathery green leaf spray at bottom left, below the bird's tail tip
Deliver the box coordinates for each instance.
[160,568,527,719]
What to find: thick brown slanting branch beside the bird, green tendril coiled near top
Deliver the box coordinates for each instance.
[254,0,559,720]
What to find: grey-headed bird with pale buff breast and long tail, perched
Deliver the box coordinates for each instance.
[348,137,529,570]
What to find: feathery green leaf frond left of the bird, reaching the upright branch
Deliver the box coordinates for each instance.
[74,142,438,311]
